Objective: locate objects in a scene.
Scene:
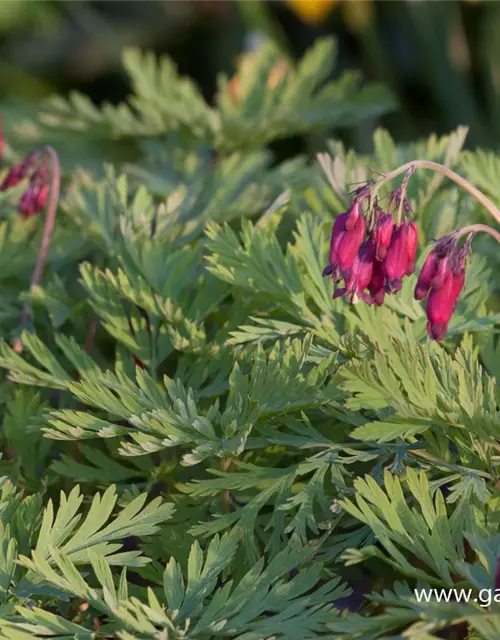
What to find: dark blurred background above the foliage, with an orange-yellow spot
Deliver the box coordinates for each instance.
[0,0,500,155]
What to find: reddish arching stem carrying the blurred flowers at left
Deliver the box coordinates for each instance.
[15,146,61,351]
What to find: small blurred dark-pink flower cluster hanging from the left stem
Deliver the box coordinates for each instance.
[0,132,49,218]
